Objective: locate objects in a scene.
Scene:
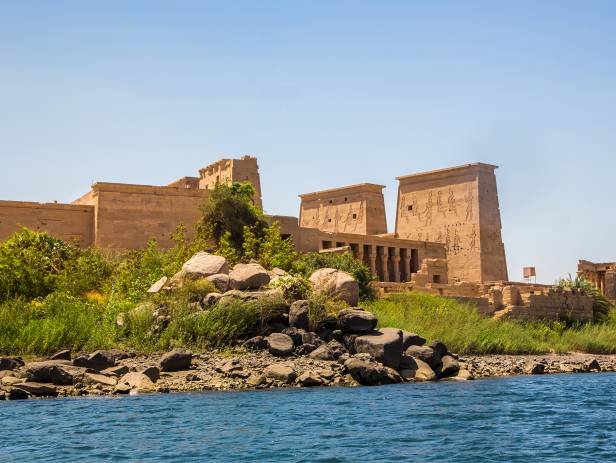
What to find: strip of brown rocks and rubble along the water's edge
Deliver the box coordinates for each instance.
[0,349,616,400]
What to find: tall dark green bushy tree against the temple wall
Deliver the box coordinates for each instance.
[199,183,267,255]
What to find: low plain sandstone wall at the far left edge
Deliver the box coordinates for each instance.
[0,201,94,247]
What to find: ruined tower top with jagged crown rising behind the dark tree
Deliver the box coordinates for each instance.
[199,156,263,209]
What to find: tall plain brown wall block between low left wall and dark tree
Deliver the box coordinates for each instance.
[78,183,209,250]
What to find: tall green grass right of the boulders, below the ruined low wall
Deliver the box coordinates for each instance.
[363,293,616,354]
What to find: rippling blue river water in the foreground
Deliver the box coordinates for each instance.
[0,374,616,462]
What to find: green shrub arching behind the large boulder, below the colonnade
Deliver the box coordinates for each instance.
[293,252,376,300]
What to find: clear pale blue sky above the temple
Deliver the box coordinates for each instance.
[0,0,616,283]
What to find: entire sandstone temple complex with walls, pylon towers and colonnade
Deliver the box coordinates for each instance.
[0,156,596,320]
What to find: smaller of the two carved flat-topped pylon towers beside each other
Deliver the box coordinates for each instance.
[299,183,387,235]
